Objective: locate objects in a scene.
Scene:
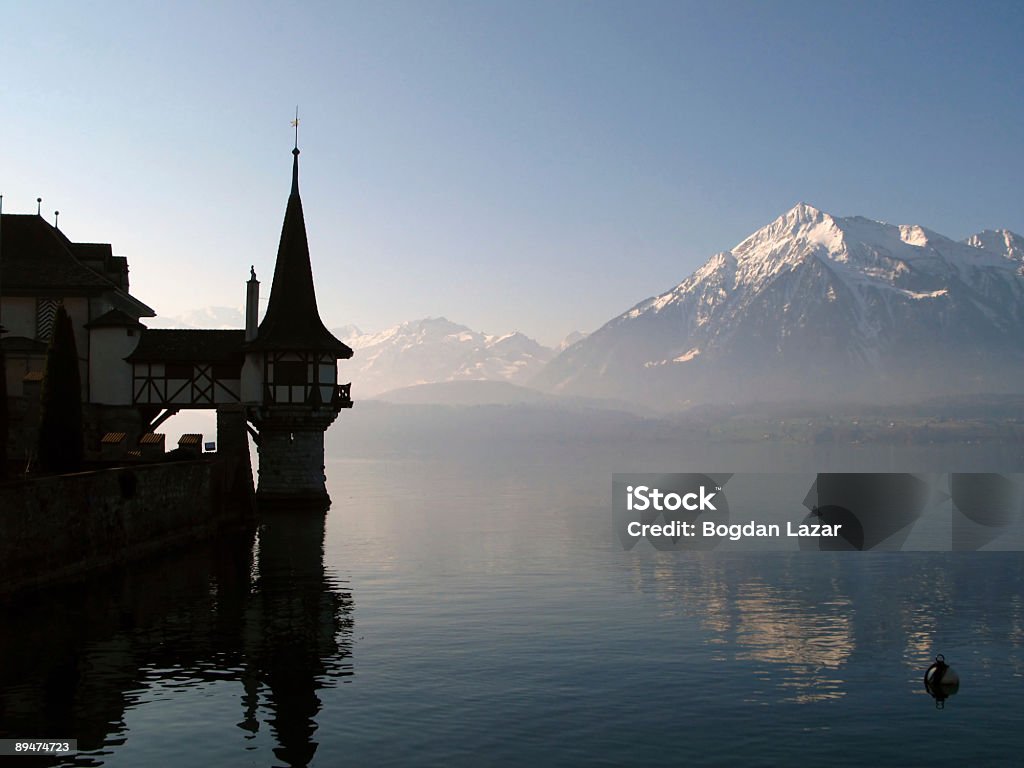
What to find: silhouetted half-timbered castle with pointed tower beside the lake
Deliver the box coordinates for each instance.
[0,146,352,506]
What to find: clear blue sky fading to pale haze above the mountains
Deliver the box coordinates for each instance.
[0,0,1024,342]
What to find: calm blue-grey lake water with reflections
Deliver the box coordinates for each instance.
[0,438,1024,766]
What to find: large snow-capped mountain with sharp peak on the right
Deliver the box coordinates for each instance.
[534,204,1024,406]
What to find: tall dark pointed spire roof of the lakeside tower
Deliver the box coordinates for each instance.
[247,150,352,358]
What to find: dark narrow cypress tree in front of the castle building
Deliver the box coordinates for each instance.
[39,304,84,472]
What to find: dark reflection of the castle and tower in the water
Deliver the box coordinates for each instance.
[0,512,353,766]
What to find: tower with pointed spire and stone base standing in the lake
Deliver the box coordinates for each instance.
[242,146,352,508]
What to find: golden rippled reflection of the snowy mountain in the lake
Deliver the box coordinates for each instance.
[629,553,1011,703]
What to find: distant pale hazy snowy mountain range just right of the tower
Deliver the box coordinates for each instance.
[338,317,554,397]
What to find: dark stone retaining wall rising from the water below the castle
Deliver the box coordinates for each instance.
[0,459,251,594]
